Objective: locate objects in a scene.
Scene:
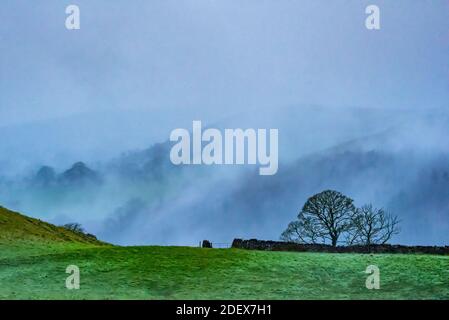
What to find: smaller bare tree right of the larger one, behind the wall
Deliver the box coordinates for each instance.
[347,204,400,247]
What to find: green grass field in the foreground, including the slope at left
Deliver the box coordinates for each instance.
[0,208,449,299]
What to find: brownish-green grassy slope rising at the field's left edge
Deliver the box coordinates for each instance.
[0,207,105,245]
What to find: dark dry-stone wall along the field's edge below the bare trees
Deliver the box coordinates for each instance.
[232,239,449,254]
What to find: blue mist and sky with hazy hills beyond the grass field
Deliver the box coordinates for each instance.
[0,0,449,245]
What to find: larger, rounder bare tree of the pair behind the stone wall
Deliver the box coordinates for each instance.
[281,190,357,247]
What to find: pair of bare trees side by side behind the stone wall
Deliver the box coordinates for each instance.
[281,190,400,247]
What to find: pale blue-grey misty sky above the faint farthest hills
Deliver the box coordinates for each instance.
[0,0,449,127]
